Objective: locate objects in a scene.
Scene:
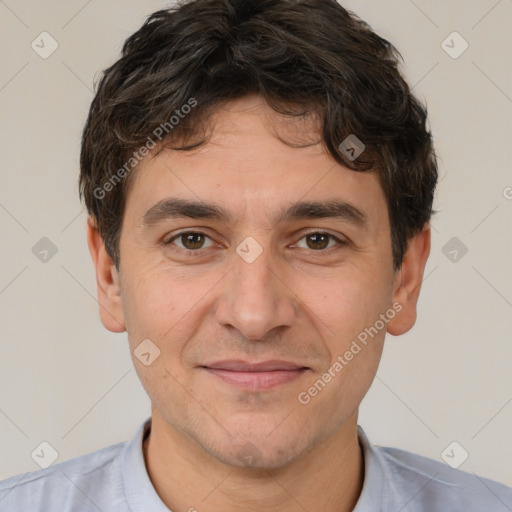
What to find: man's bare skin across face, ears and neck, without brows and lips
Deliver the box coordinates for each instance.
[88,96,430,512]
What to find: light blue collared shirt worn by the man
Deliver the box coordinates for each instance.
[0,418,512,512]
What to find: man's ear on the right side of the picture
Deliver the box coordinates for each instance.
[387,224,430,336]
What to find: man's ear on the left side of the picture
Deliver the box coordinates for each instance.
[87,217,126,332]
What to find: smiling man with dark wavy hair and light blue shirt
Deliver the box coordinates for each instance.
[0,0,512,512]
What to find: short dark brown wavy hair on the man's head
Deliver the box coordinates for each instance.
[79,0,437,269]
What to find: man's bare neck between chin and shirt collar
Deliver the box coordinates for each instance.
[143,411,364,512]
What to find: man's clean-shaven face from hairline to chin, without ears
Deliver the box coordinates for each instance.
[108,97,404,467]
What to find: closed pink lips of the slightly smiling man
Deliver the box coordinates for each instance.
[201,360,310,391]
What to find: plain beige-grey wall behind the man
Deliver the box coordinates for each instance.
[0,0,512,486]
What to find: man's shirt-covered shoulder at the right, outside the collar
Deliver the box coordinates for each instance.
[374,447,512,512]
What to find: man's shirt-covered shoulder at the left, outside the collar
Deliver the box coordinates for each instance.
[0,443,126,512]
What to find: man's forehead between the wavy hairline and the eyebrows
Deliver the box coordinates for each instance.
[126,97,387,227]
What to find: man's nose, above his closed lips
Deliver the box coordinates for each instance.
[216,242,297,341]
